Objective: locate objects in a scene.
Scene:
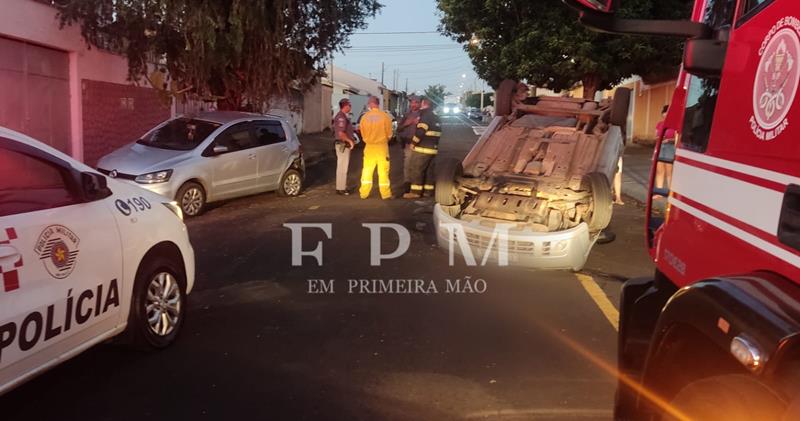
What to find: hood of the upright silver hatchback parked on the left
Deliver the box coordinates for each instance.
[97,143,193,175]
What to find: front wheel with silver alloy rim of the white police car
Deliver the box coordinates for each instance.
[127,257,187,349]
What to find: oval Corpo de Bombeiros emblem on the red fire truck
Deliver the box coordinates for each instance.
[750,17,800,140]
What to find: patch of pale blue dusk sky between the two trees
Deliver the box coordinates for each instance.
[334,0,490,99]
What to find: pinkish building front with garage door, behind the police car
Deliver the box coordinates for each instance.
[0,0,171,165]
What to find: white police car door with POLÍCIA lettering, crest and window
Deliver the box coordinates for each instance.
[0,136,122,390]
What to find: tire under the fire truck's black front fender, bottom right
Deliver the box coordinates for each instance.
[662,374,785,421]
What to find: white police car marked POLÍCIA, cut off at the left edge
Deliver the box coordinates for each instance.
[0,127,195,394]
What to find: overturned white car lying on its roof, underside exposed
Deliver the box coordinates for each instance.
[434,80,630,270]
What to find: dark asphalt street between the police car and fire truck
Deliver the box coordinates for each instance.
[0,112,652,421]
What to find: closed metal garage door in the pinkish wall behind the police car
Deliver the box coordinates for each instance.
[0,37,70,153]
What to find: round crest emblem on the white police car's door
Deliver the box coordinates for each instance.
[34,225,80,279]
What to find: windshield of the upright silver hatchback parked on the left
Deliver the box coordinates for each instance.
[136,118,220,151]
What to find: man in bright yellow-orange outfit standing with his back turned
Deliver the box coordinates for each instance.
[358,96,392,199]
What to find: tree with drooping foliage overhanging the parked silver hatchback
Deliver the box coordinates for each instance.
[53,0,382,110]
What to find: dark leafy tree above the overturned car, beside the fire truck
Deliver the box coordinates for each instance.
[437,0,690,98]
